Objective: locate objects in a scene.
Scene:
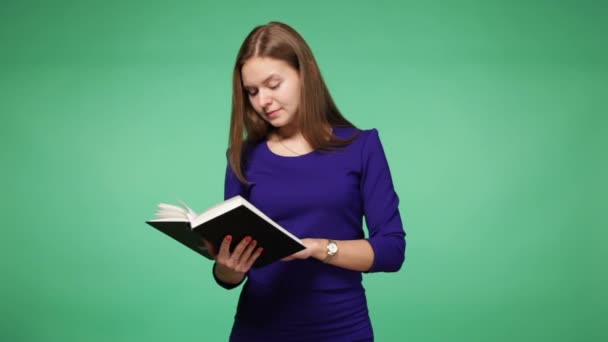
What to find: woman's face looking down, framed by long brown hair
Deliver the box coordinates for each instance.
[241,57,300,128]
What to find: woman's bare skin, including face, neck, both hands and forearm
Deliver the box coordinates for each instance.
[205,57,374,284]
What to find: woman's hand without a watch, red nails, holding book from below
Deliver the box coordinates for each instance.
[203,235,263,284]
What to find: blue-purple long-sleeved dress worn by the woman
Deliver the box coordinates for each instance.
[216,127,405,342]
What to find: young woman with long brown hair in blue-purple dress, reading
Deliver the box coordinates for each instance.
[208,22,405,342]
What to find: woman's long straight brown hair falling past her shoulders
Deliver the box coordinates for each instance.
[228,22,356,183]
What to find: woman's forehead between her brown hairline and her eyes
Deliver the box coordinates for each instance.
[241,57,297,87]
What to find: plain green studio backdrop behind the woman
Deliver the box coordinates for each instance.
[0,0,608,341]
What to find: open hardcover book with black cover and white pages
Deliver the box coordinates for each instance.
[146,196,305,267]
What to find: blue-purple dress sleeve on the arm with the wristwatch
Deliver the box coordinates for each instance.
[361,129,405,272]
